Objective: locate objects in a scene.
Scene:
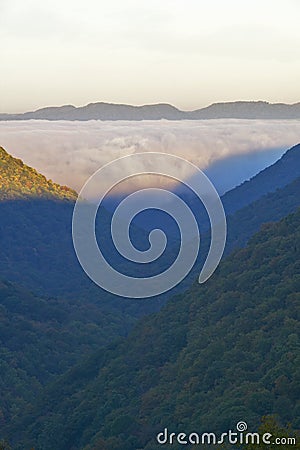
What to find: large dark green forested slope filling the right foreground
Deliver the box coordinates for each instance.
[4,209,300,450]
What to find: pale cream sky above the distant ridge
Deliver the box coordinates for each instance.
[0,0,300,112]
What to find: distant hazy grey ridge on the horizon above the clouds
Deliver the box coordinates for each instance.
[0,101,300,120]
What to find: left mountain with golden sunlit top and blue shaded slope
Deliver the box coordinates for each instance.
[0,148,152,300]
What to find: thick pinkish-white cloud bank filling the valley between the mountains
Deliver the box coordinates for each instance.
[0,120,300,198]
